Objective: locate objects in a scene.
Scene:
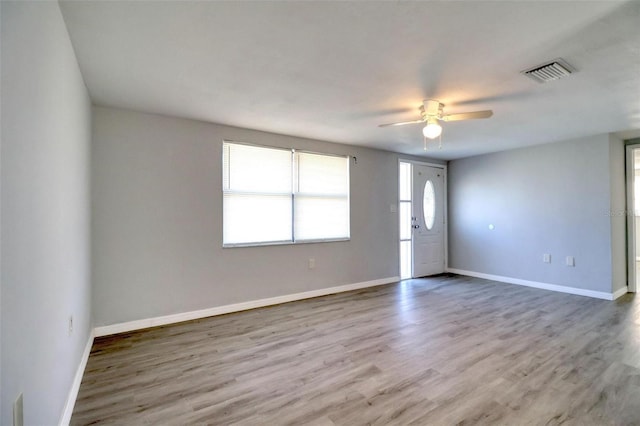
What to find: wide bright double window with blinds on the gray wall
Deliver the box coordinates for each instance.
[223,142,350,247]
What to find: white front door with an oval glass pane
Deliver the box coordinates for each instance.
[411,164,445,278]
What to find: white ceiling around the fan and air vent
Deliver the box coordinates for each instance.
[61,1,640,159]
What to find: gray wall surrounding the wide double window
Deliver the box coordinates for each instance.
[92,107,424,326]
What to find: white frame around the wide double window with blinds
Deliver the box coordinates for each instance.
[220,139,351,248]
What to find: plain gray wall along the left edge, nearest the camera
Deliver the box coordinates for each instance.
[0,1,91,425]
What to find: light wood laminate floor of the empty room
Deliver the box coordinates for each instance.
[71,275,640,425]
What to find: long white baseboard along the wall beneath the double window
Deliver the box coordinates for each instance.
[94,277,400,337]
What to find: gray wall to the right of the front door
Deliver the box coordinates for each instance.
[449,135,626,293]
